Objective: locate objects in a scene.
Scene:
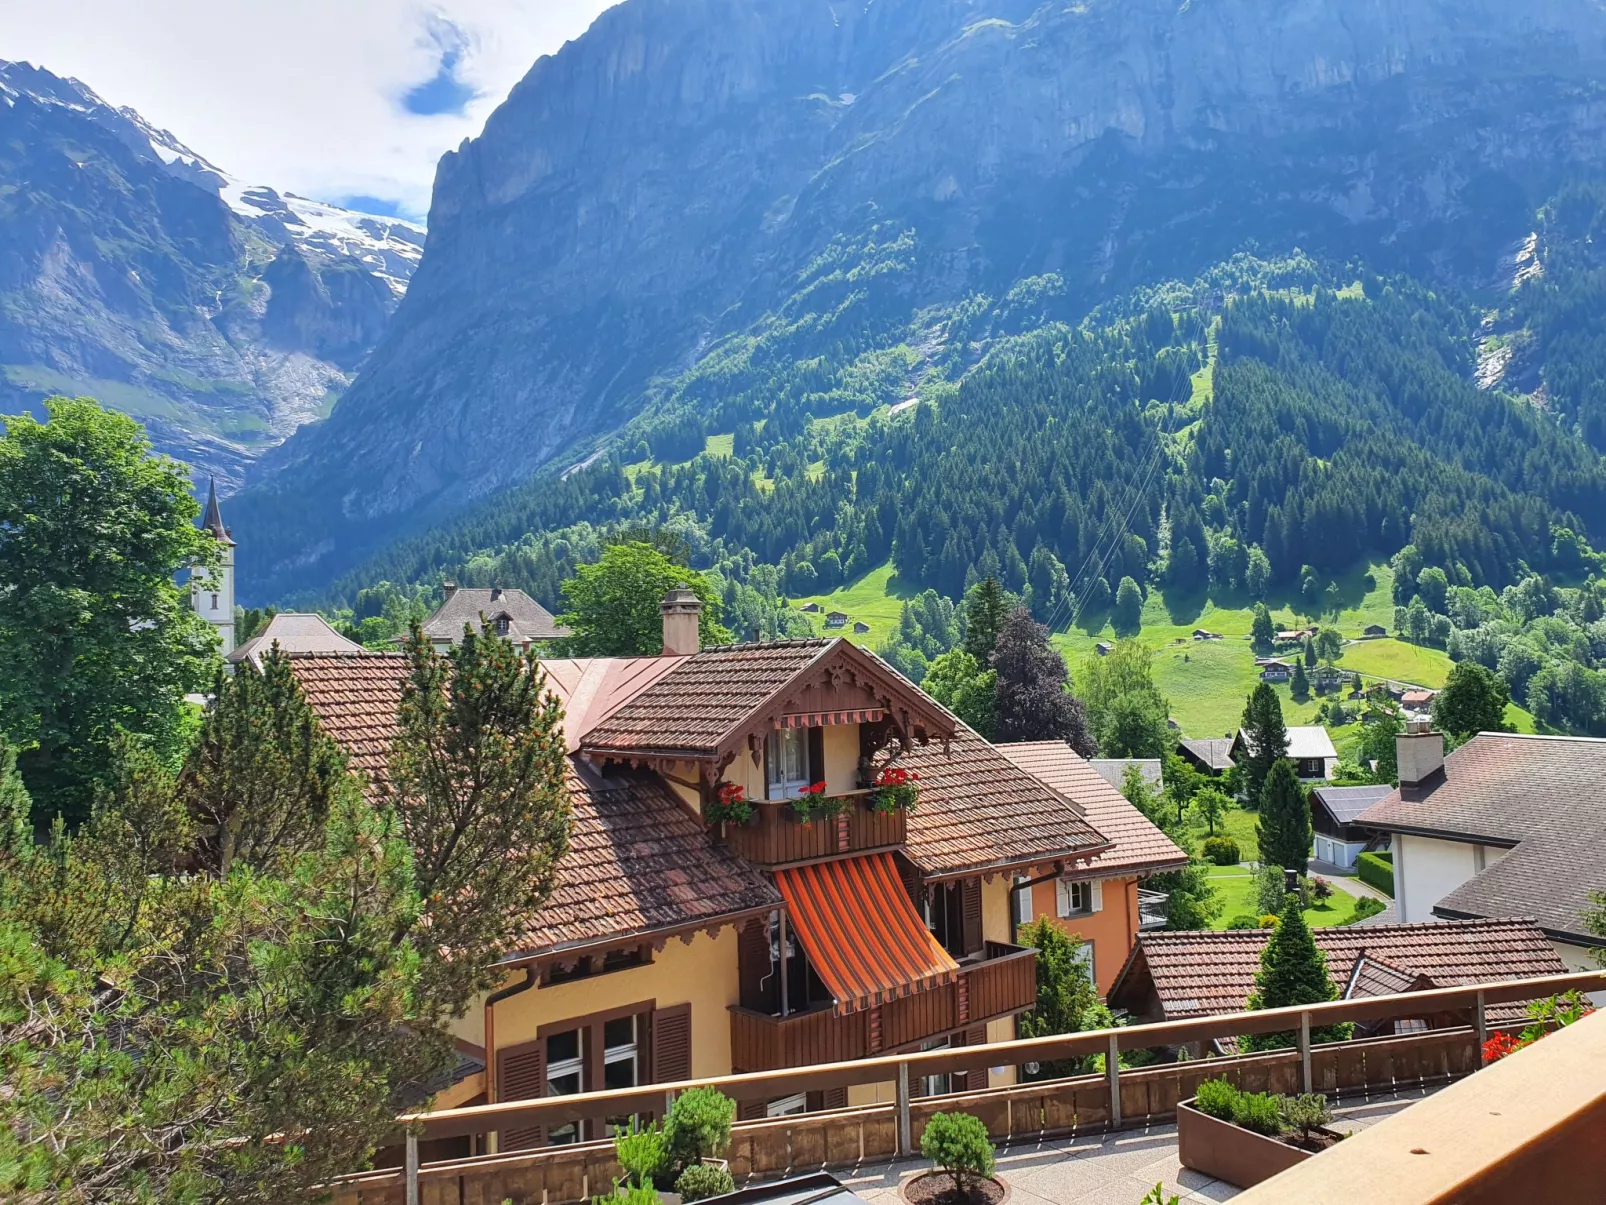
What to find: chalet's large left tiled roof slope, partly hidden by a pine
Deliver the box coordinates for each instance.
[291,652,781,954]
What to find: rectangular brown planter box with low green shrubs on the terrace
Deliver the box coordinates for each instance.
[1177,1080,1344,1189]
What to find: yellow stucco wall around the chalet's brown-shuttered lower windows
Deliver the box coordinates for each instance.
[453,925,740,1076]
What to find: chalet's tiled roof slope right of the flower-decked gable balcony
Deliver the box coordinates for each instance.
[895,725,1108,876]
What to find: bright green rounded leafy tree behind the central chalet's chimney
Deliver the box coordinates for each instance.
[559,541,732,657]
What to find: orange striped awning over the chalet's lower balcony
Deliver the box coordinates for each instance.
[776,853,959,1012]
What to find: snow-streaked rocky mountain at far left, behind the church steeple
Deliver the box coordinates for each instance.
[0,63,424,482]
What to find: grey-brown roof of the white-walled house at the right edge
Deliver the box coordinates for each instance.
[1360,733,1606,945]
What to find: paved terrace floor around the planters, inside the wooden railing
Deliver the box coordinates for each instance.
[837,1088,1437,1205]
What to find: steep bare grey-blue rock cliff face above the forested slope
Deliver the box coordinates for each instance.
[234,0,1606,593]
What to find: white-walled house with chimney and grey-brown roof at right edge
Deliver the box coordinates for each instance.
[1359,720,1606,1003]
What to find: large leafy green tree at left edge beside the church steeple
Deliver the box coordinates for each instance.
[0,397,220,824]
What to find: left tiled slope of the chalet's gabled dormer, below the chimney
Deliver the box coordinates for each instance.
[585,639,837,754]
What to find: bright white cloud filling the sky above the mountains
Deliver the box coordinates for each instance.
[0,0,613,215]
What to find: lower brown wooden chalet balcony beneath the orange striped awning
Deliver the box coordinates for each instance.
[731,942,1037,1072]
